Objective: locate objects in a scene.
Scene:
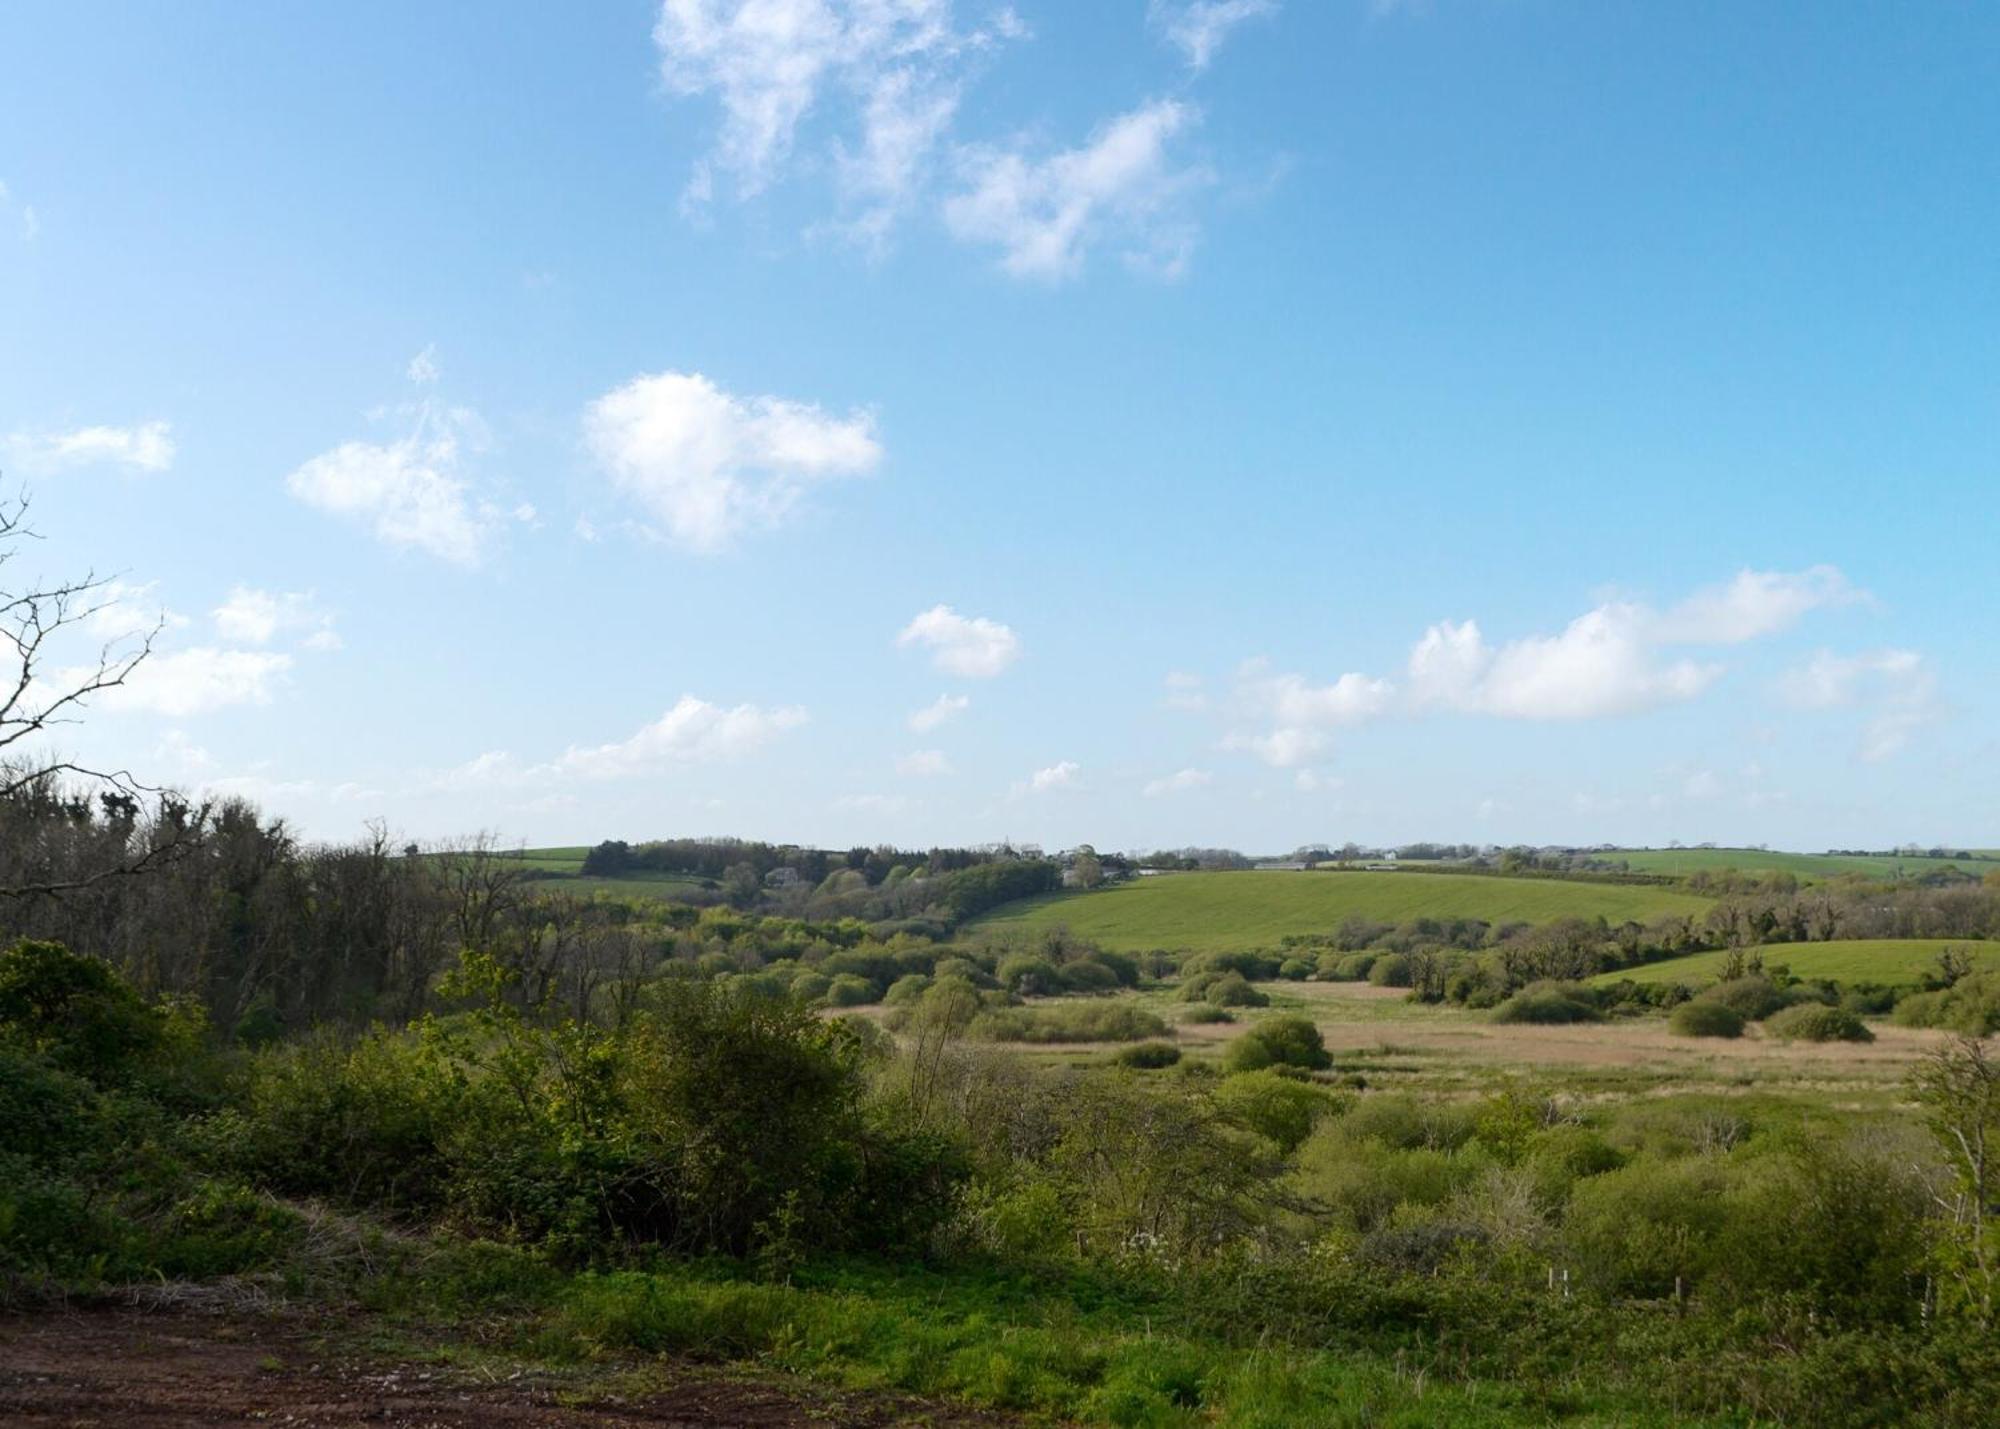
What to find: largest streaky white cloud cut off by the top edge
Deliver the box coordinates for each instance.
[652,0,1026,244]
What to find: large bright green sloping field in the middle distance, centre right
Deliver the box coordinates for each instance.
[970,873,1708,951]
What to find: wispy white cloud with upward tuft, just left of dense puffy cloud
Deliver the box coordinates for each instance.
[284,400,500,566]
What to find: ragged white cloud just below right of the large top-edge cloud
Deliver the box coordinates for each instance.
[944,100,1208,280]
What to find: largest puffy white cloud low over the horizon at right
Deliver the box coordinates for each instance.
[1410,604,1722,721]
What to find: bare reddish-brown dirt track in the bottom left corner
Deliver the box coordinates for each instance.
[0,1309,1004,1429]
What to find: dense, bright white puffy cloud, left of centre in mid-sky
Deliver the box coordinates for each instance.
[584,372,882,550]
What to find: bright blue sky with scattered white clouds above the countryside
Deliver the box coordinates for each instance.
[0,0,2000,849]
